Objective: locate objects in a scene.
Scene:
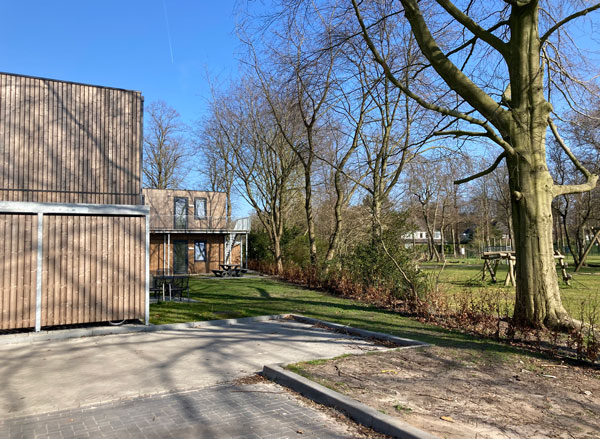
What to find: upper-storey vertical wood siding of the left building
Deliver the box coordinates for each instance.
[0,73,142,204]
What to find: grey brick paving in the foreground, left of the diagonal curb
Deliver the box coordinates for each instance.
[0,384,360,439]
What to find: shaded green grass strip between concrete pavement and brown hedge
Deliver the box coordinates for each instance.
[150,277,548,360]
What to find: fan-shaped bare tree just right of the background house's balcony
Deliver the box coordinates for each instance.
[207,77,298,272]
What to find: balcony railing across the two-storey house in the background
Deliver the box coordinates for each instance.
[150,217,250,233]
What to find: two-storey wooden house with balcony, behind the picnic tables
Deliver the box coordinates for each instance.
[143,189,250,274]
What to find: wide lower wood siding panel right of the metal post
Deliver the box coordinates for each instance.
[42,215,146,326]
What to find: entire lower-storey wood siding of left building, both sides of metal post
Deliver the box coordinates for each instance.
[0,214,146,329]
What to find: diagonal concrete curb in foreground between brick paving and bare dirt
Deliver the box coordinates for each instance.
[263,364,439,439]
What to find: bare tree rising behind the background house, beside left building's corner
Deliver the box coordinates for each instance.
[144,101,188,189]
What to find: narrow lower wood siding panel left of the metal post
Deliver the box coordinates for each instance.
[0,215,37,329]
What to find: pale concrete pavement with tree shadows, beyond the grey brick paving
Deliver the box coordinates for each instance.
[0,320,384,419]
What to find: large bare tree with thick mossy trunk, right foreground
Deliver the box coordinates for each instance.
[352,0,600,328]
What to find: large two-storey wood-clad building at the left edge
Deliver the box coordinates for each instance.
[0,73,149,330]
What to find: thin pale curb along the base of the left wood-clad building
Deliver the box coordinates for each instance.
[0,314,289,346]
